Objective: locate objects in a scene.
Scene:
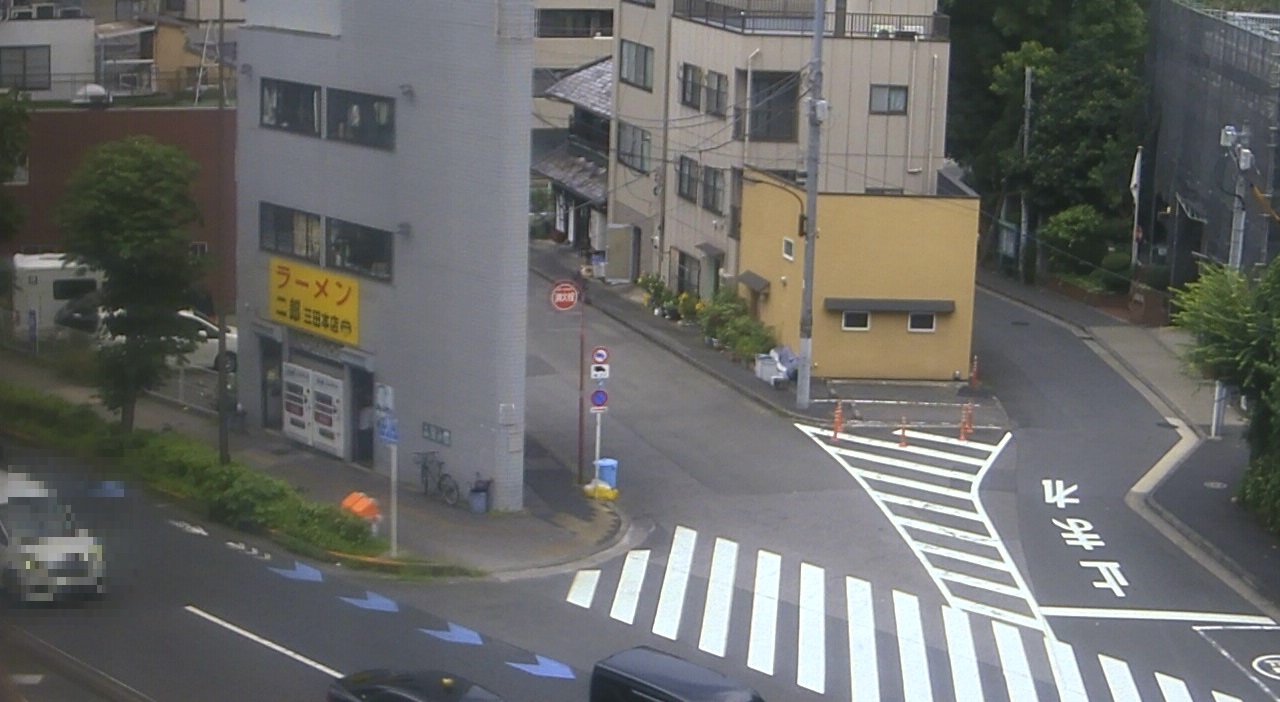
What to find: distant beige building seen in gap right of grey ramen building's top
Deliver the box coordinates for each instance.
[534,0,618,152]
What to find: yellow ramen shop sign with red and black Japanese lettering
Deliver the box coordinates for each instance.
[266,256,360,346]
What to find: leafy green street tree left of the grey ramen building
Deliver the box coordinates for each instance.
[58,137,202,432]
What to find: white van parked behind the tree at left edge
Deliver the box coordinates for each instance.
[12,254,104,341]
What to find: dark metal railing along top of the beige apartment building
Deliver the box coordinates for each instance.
[675,0,951,41]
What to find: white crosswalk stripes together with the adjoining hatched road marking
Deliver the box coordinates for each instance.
[566,425,1242,702]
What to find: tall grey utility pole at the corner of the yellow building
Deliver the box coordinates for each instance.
[793,0,827,410]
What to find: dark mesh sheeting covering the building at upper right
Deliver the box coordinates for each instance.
[1140,0,1280,283]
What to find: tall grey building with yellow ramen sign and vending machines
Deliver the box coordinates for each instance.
[236,0,534,510]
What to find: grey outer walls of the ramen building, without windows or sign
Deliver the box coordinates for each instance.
[237,0,532,509]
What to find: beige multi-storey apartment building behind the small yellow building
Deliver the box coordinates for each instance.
[596,0,950,297]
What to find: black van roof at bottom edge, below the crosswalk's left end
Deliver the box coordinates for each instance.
[595,646,764,702]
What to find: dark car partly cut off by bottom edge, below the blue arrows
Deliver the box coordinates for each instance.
[328,669,503,702]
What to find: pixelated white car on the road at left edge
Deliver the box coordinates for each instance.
[0,494,106,602]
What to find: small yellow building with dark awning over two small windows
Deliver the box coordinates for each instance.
[737,169,978,380]
